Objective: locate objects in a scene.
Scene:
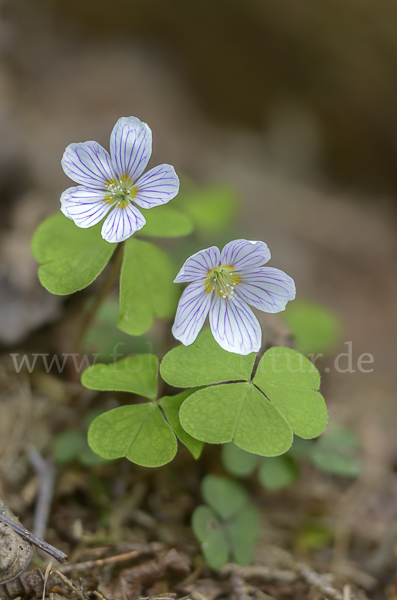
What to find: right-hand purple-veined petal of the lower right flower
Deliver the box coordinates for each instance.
[235,267,295,313]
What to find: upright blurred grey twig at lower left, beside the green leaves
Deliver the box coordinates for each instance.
[27,444,55,538]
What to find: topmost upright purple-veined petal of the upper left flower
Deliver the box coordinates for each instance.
[110,117,152,182]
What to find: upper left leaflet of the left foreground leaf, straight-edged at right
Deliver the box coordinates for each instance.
[81,354,158,400]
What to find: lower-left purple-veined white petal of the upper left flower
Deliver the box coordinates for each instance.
[61,185,111,229]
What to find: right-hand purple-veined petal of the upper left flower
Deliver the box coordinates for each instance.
[134,165,179,208]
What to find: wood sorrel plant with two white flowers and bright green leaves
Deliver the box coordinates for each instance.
[33,117,327,486]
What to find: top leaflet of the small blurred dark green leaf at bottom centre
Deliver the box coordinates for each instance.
[201,475,248,520]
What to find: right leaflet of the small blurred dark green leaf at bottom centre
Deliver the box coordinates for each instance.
[226,504,260,565]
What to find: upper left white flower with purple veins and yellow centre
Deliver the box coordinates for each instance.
[61,117,179,242]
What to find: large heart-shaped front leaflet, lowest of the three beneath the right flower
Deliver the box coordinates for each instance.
[179,383,293,456]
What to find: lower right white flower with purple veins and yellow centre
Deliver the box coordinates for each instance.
[172,240,295,354]
